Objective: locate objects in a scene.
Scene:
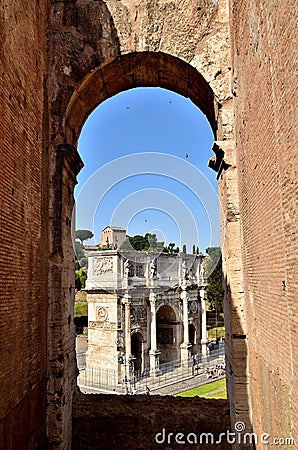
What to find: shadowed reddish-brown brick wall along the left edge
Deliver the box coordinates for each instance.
[0,0,48,450]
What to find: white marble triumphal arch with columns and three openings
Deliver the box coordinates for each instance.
[85,250,207,383]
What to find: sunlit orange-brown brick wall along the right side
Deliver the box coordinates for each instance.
[230,0,298,448]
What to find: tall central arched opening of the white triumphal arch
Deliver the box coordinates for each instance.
[156,305,181,363]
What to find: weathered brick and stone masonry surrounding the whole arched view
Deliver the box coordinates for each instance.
[0,0,298,450]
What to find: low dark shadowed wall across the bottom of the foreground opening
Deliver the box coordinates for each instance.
[73,393,230,450]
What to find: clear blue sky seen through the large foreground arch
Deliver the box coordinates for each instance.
[75,88,220,252]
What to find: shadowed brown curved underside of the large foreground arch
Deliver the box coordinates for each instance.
[65,52,220,144]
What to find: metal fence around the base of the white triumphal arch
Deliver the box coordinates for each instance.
[77,346,224,393]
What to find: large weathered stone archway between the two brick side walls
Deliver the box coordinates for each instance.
[48,0,246,440]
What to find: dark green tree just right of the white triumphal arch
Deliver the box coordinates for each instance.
[206,247,224,312]
